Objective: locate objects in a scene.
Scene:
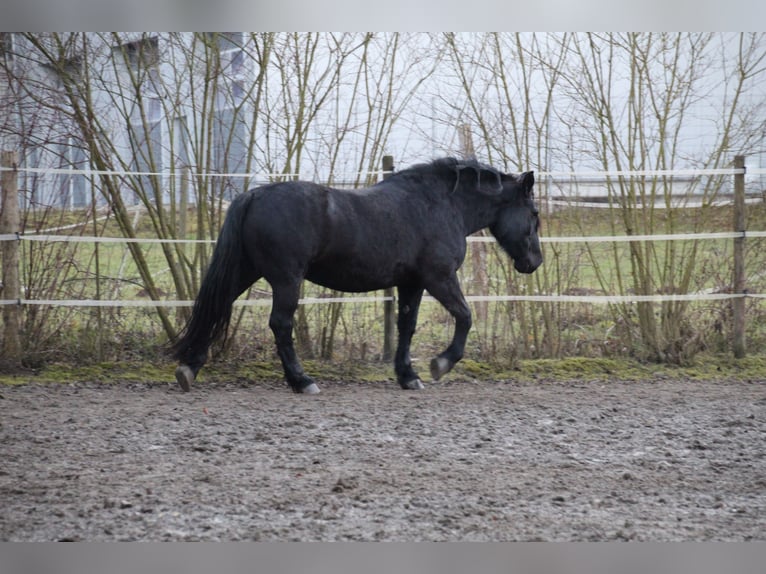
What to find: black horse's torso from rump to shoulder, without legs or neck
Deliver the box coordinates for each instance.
[244,182,464,292]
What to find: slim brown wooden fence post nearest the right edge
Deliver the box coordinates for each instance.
[731,155,747,359]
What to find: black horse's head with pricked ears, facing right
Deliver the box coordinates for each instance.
[489,171,543,273]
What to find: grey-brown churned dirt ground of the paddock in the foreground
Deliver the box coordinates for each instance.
[0,373,766,541]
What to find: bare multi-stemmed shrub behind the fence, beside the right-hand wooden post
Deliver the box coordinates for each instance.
[562,33,764,362]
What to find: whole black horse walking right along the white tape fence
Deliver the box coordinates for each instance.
[171,158,543,393]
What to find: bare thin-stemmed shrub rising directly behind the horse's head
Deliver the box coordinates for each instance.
[436,33,569,360]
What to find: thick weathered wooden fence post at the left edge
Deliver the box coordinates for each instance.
[0,151,21,366]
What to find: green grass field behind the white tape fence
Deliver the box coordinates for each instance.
[10,200,766,368]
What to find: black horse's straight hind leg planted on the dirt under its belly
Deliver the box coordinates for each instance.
[269,282,319,394]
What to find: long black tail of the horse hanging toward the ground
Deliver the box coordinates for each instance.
[169,193,253,366]
